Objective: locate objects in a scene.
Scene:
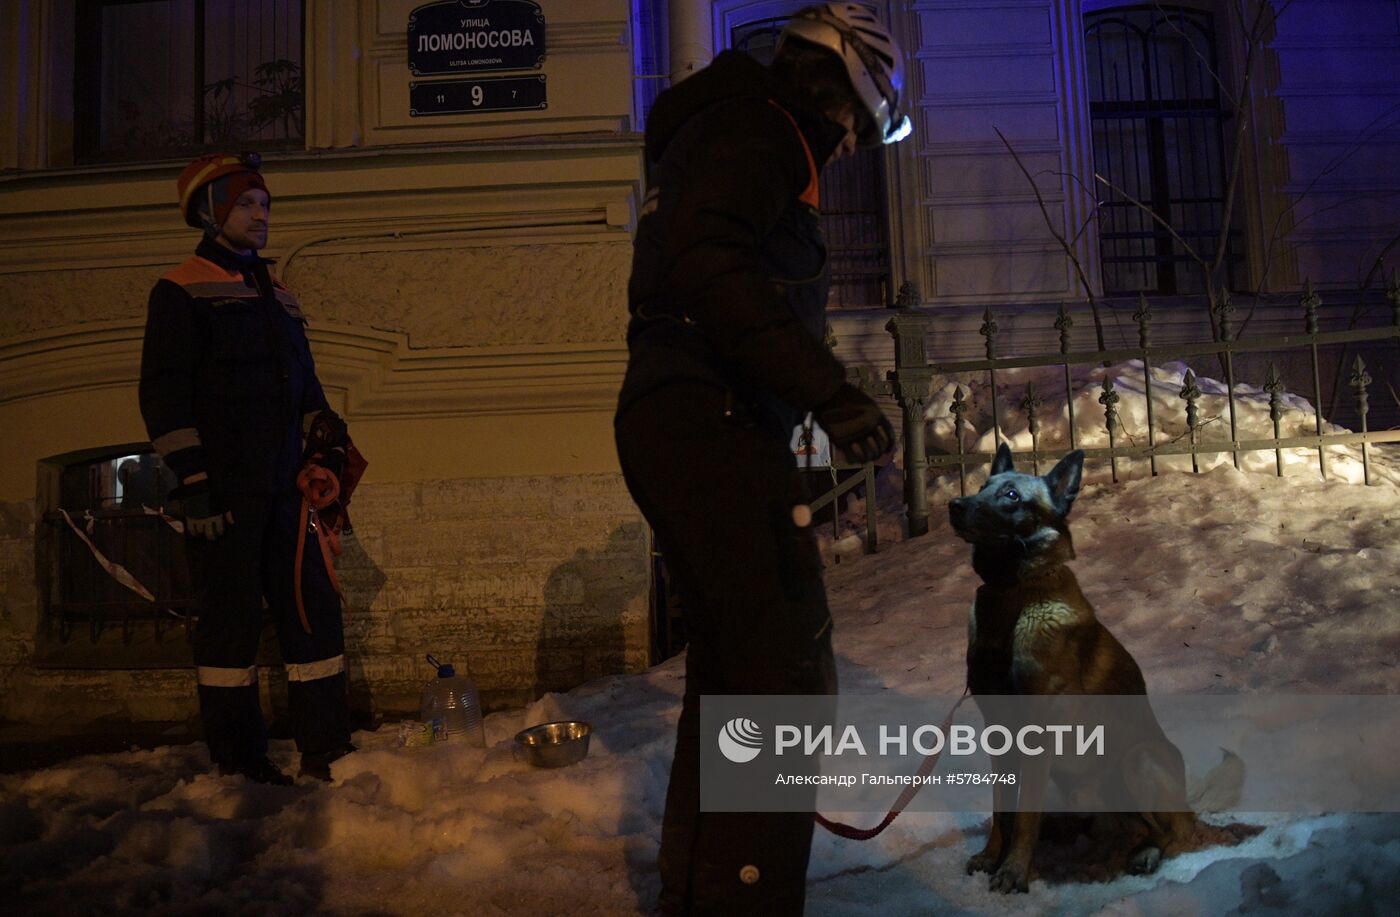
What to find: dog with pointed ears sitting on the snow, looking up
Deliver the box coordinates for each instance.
[949,444,1243,892]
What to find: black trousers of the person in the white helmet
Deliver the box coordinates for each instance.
[615,382,836,917]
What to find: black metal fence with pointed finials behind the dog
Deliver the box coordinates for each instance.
[864,280,1400,536]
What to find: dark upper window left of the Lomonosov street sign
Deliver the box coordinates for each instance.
[74,0,305,162]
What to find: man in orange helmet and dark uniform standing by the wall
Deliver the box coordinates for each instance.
[140,154,353,784]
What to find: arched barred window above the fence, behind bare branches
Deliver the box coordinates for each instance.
[1085,4,1239,294]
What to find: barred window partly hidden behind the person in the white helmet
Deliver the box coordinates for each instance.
[729,17,889,309]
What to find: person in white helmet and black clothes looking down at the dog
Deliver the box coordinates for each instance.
[615,3,909,917]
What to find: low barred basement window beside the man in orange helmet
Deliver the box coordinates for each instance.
[38,442,192,652]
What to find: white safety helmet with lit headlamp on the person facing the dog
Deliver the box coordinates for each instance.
[778,3,911,143]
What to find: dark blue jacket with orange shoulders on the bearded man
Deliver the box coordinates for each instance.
[140,238,326,497]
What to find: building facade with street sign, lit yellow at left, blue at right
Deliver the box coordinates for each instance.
[0,0,1400,721]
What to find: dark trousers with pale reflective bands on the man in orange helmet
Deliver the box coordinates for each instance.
[186,493,350,769]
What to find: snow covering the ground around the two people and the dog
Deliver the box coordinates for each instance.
[0,365,1400,916]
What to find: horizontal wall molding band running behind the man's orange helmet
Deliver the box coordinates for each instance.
[0,137,641,275]
